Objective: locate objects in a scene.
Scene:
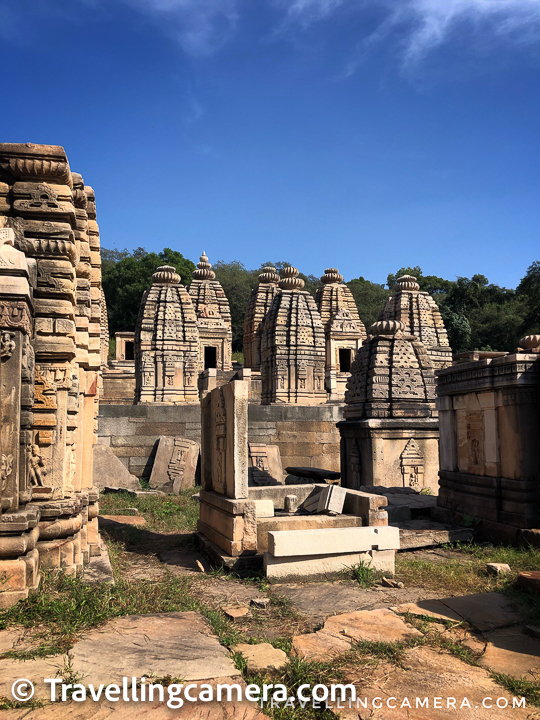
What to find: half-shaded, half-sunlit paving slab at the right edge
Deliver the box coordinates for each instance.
[479,627,540,680]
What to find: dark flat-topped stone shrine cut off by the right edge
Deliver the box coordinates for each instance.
[437,335,540,542]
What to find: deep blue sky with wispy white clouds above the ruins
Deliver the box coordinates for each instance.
[0,0,540,287]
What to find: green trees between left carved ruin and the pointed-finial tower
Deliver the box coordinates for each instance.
[102,248,195,336]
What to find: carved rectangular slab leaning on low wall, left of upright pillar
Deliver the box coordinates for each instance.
[150,437,200,495]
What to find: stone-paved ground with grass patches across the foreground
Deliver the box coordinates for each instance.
[0,495,540,720]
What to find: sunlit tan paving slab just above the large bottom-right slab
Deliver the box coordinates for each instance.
[324,609,423,642]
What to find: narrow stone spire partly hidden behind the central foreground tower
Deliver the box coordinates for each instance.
[244,267,280,373]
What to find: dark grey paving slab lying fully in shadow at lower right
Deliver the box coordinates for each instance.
[441,593,522,631]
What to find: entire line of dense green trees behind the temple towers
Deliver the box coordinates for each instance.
[102,248,540,352]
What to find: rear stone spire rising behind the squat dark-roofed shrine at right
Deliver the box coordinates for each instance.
[379,275,452,370]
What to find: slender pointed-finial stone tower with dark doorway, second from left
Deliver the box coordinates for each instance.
[188,252,232,371]
